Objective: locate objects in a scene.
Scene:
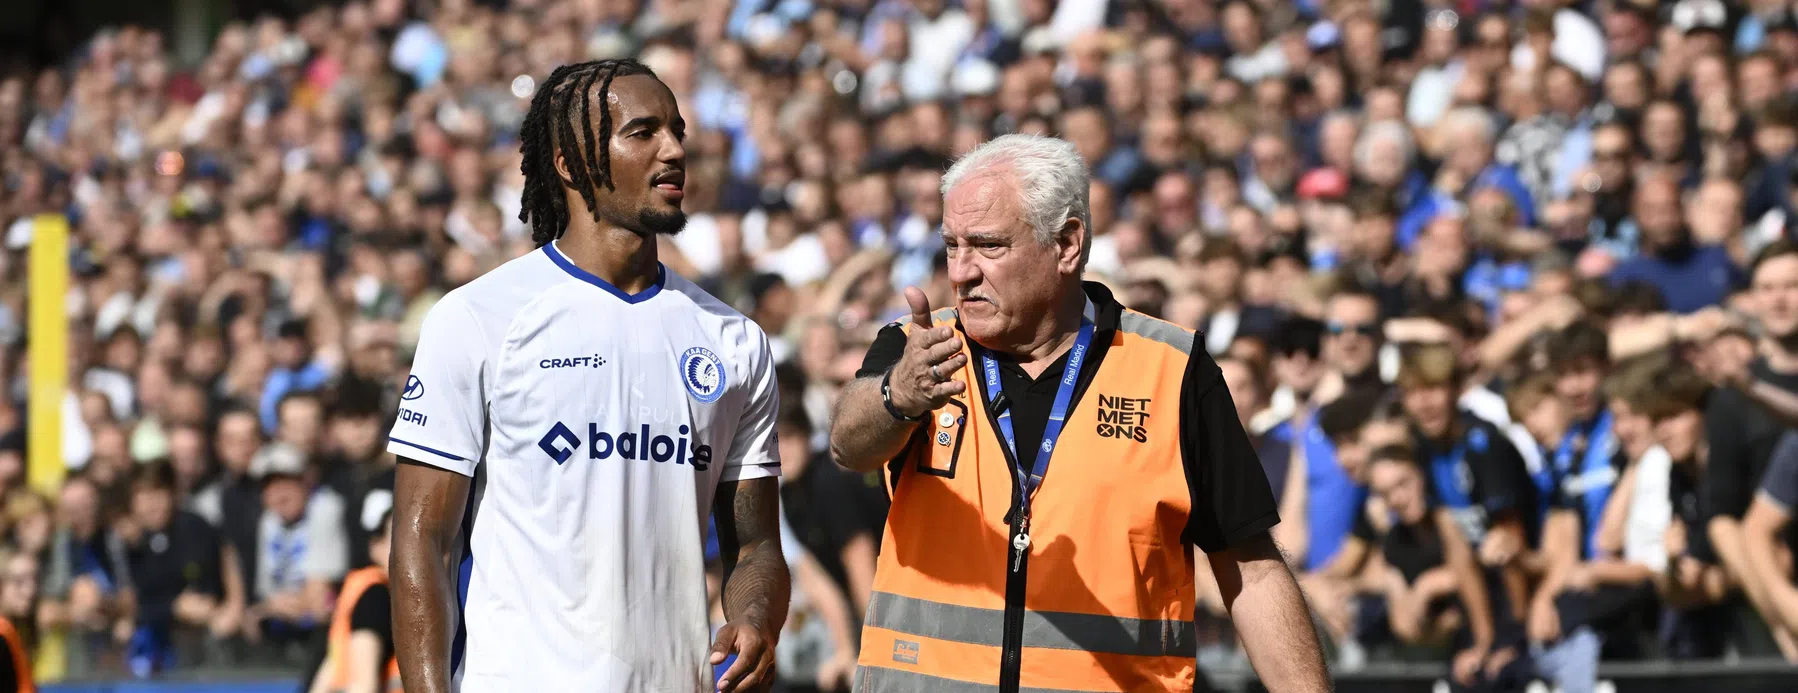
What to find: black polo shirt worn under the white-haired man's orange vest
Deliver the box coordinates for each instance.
[856,283,1280,553]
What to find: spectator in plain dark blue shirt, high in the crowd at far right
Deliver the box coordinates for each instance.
[1611,178,1742,313]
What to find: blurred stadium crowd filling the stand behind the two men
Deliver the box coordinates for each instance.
[0,0,1798,689]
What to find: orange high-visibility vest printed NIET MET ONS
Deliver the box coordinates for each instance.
[856,295,1197,693]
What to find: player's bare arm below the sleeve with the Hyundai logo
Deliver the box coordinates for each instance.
[392,459,469,693]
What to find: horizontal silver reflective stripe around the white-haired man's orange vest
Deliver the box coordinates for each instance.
[868,592,1197,657]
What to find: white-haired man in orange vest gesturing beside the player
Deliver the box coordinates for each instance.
[831,135,1329,693]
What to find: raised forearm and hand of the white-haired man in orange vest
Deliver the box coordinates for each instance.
[831,288,967,472]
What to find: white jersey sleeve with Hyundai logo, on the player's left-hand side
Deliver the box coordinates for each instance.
[387,297,487,477]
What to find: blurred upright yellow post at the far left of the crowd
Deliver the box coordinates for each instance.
[25,208,68,680]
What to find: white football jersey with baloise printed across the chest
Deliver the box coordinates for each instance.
[387,243,780,693]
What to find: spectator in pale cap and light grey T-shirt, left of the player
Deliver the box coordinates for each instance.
[243,443,349,657]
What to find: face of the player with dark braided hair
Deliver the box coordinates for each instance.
[575,74,687,236]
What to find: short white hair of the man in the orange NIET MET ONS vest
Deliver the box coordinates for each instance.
[942,135,1093,266]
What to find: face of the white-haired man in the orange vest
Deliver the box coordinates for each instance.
[942,166,1086,347]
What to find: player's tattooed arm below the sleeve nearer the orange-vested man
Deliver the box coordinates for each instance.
[712,477,791,634]
